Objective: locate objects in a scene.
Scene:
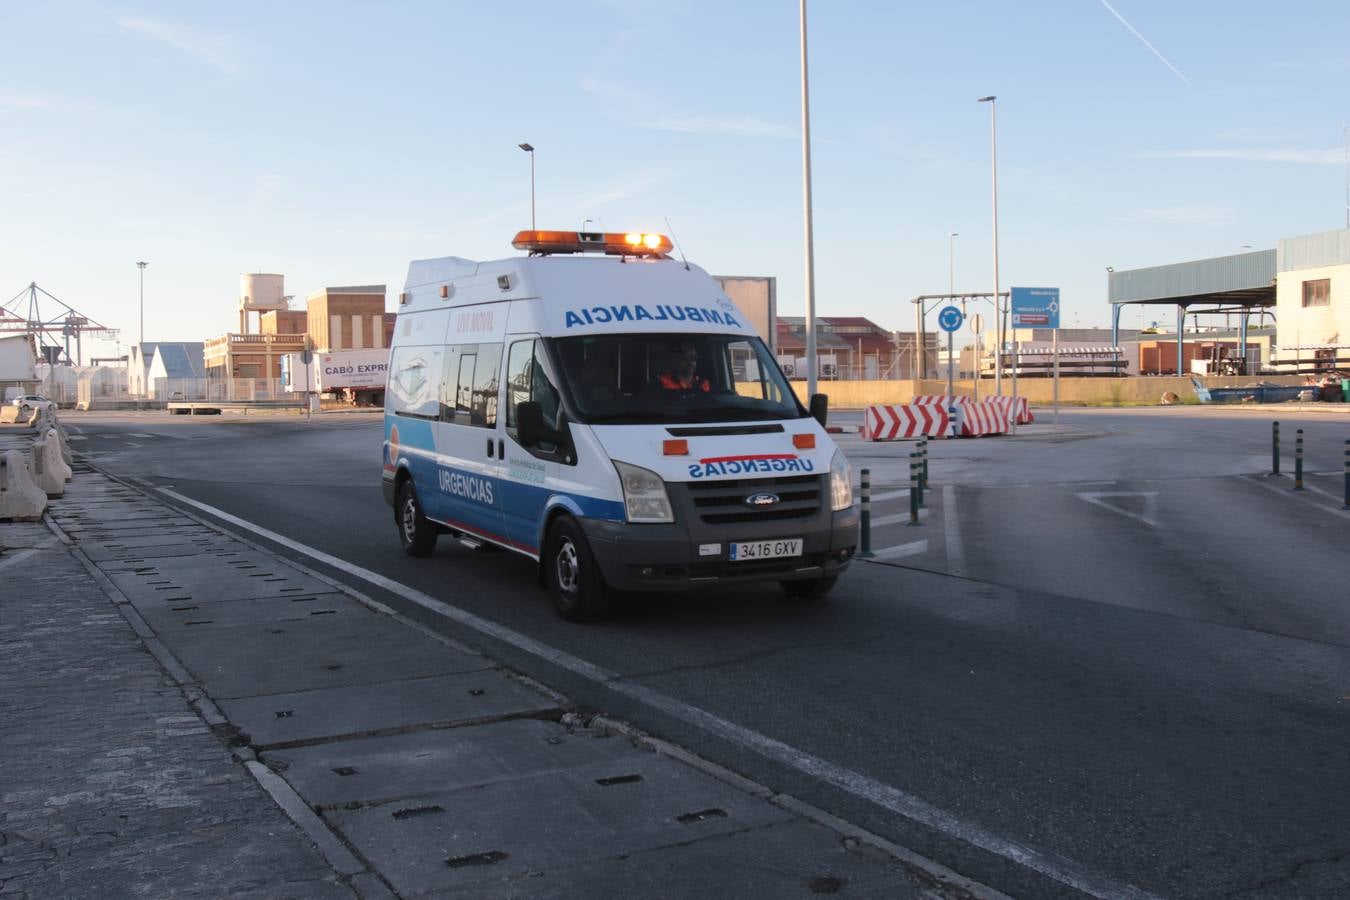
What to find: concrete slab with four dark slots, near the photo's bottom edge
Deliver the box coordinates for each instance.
[324,754,791,896]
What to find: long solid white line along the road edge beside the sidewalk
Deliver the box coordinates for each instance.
[159,487,1157,900]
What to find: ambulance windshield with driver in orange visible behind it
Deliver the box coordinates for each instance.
[552,333,806,425]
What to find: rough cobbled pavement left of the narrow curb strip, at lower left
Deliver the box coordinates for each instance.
[0,518,352,897]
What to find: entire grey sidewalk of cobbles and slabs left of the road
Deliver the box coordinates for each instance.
[0,461,999,900]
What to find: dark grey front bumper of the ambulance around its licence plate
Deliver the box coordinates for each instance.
[582,484,859,591]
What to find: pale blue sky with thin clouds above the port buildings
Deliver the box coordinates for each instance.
[0,0,1350,358]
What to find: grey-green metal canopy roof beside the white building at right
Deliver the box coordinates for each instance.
[1107,250,1276,309]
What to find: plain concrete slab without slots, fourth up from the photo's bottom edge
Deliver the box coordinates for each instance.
[162,612,490,698]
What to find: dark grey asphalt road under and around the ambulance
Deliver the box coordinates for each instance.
[65,407,1350,897]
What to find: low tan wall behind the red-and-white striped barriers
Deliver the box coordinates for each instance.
[792,375,1304,409]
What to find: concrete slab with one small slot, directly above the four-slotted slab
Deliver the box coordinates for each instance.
[262,719,651,808]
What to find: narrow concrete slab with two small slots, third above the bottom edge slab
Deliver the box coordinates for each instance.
[220,671,560,750]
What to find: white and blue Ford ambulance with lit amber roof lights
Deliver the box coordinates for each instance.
[383,231,859,621]
